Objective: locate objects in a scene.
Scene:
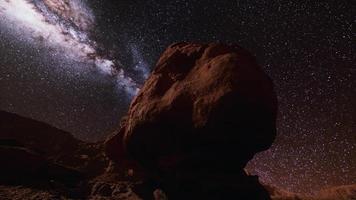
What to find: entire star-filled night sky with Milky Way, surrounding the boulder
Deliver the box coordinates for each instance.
[0,0,356,195]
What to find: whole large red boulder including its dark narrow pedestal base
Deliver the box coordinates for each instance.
[106,43,277,199]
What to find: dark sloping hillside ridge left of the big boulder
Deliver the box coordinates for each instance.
[0,111,106,176]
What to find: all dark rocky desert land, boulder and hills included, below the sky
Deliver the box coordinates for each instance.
[0,42,356,200]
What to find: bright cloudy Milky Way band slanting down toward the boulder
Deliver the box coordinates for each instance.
[0,0,147,97]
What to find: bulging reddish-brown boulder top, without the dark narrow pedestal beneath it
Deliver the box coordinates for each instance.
[108,43,277,167]
